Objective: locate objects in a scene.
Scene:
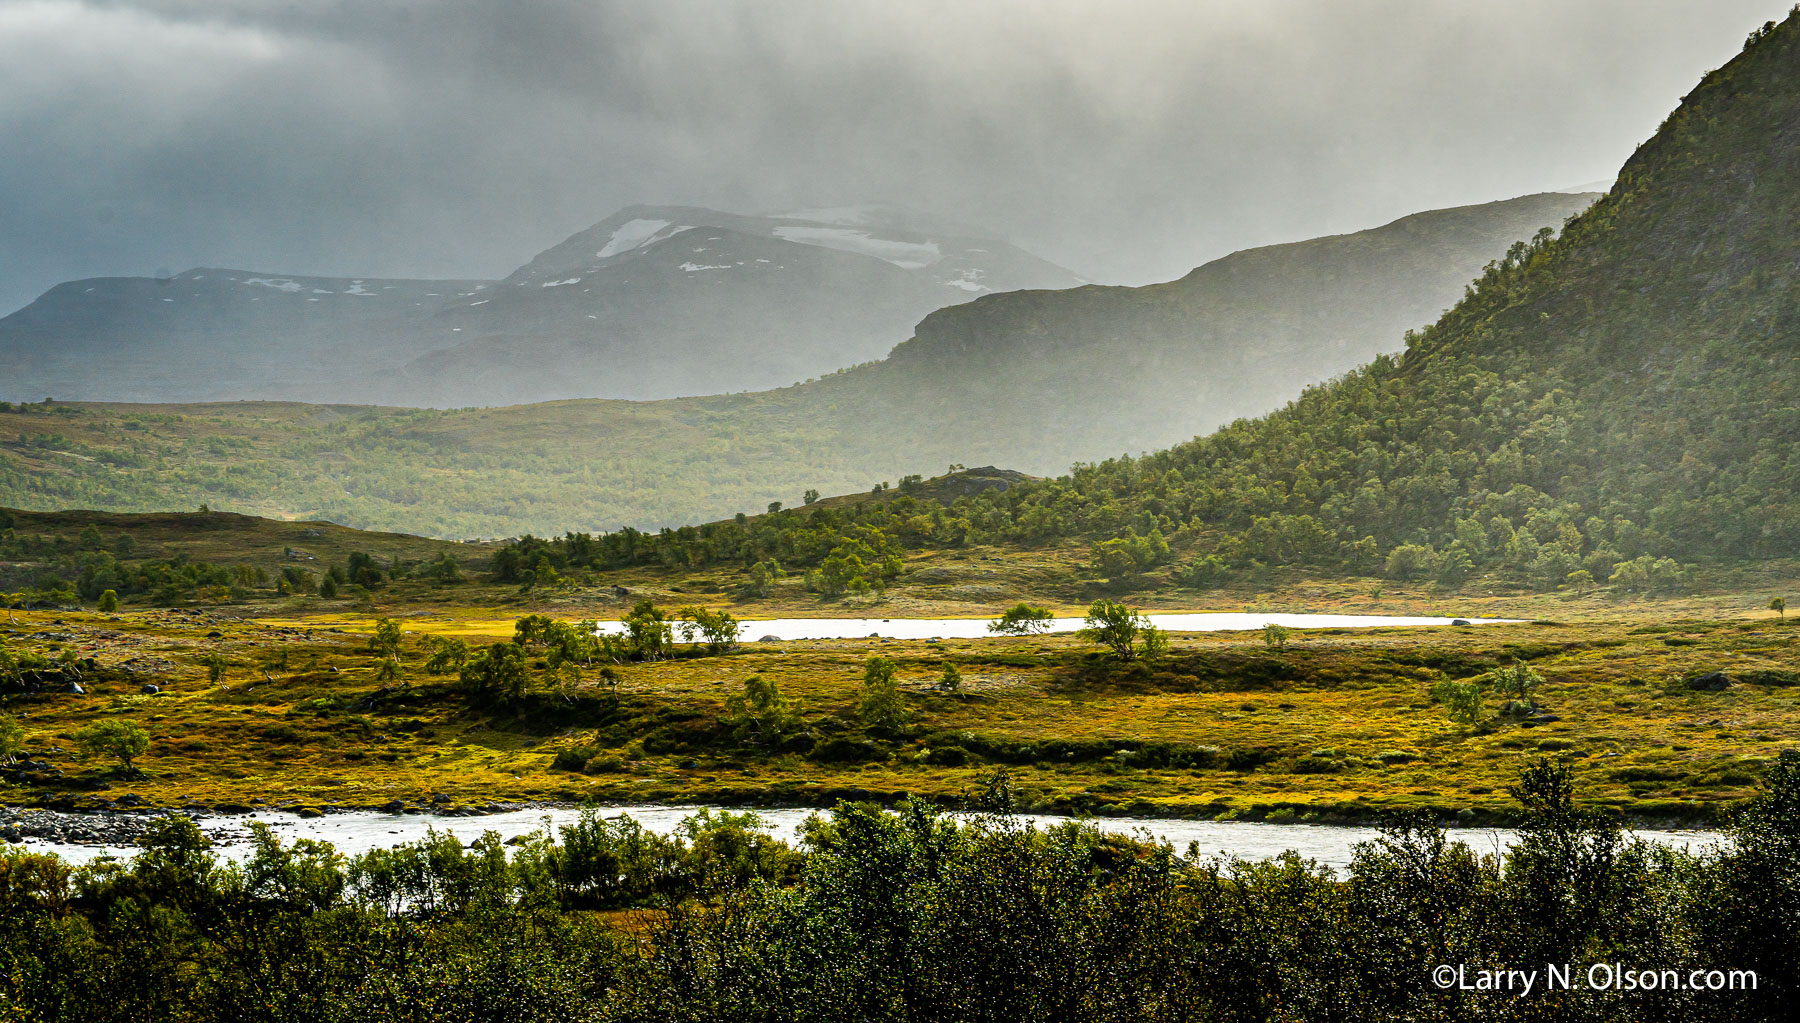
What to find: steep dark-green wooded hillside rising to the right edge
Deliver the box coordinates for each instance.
[464,7,1800,591]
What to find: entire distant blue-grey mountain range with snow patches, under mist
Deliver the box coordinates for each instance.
[0,204,1082,407]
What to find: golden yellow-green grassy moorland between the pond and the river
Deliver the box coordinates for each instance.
[0,596,1800,821]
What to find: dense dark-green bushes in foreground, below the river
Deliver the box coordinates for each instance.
[0,751,1800,1023]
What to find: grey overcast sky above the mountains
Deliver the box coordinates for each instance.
[0,0,1791,312]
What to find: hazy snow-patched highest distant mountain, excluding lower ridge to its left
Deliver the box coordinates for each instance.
[408,204,1082,405]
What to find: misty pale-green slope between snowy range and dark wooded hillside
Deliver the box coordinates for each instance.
[0,195,1591,537]
